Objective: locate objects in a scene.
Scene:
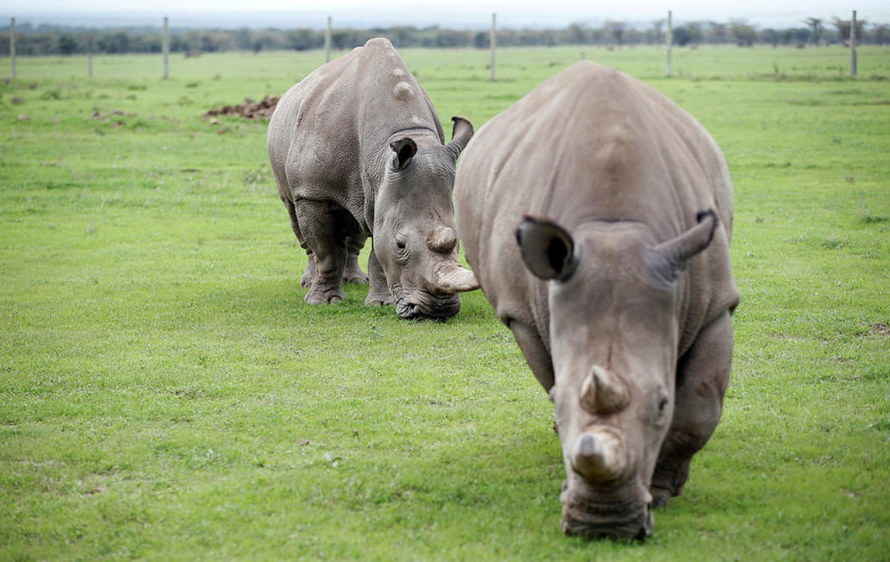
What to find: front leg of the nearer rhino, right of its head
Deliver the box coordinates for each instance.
[651,311,733,507]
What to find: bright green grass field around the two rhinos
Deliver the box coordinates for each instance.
[0,48,890,562]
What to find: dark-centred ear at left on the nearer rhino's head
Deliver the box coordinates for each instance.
[516,216,578,281]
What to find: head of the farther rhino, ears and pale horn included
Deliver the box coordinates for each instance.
[373,117,479,320]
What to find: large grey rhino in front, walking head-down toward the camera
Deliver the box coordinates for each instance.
[455,62,739,537]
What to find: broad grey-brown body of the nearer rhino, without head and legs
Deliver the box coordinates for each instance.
[455,62,738,353]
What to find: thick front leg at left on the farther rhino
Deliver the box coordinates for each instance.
[294,199,348,304]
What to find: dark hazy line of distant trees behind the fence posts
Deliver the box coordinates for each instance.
[0,18,890,56]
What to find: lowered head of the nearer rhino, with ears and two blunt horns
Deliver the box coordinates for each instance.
[516,211,717,538]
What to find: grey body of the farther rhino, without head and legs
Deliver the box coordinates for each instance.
[267,39,444,222]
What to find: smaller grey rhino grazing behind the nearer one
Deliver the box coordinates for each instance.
[268,39,479,319]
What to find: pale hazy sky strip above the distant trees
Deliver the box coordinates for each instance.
[0,0,890,28]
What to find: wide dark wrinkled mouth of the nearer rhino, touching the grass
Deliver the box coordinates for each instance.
[560,478,654,540]
